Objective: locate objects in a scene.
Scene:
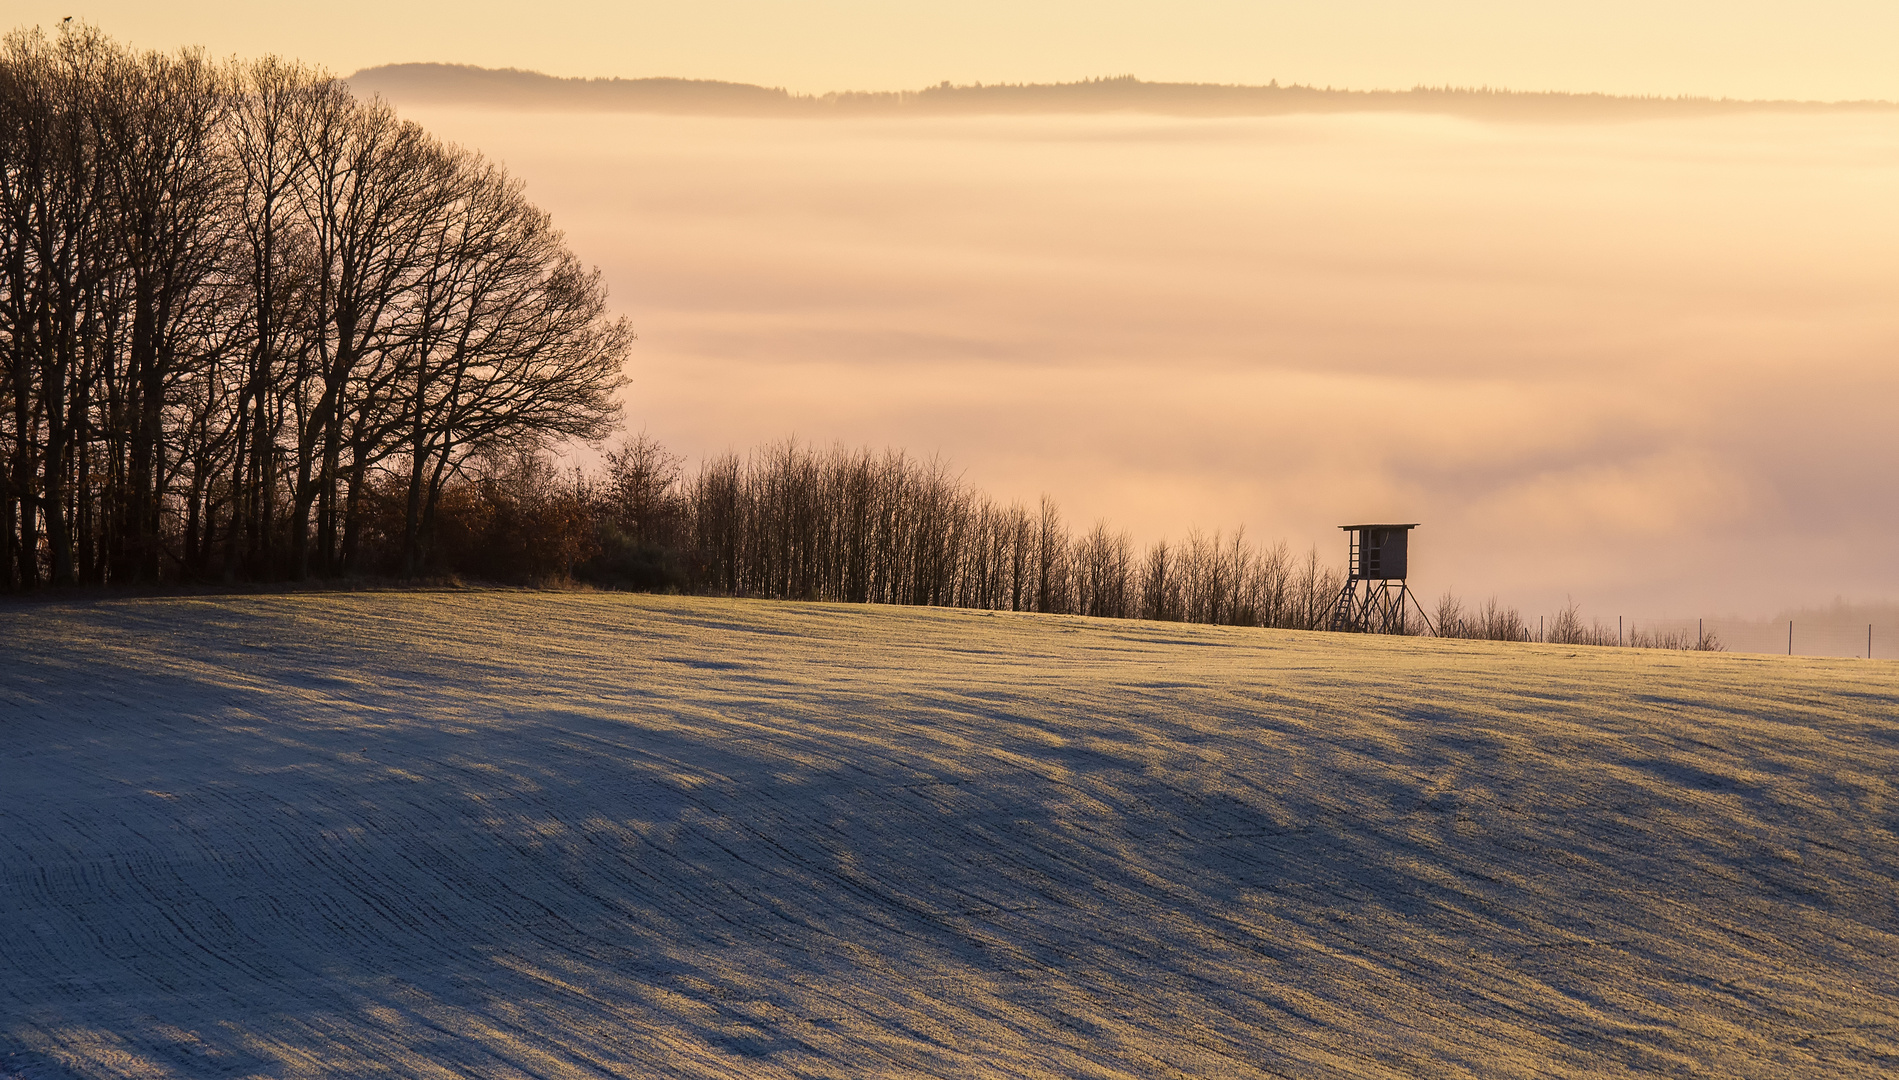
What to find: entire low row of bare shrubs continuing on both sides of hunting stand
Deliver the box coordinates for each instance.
[478,435,1722,649]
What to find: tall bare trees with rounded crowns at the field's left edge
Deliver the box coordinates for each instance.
[0,23,630,590]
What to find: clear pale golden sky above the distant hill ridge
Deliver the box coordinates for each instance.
[22,0,1899,101]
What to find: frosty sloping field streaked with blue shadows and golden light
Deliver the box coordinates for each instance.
[0,592,1899,1078]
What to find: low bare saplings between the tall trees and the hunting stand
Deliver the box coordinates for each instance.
[570,437,1343,630]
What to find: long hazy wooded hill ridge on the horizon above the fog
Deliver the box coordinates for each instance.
[348,65,1899,121]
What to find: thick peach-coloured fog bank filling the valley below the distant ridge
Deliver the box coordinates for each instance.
[404,106,1899,621]
